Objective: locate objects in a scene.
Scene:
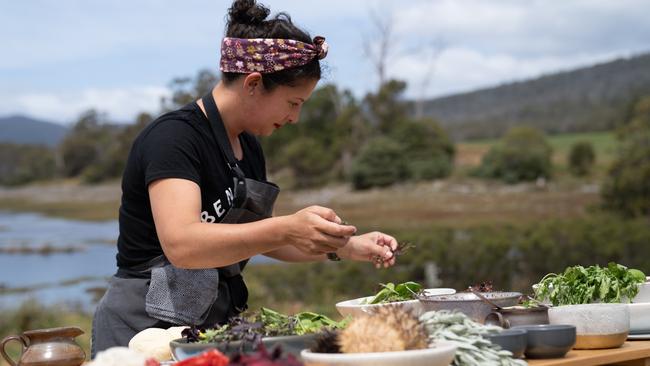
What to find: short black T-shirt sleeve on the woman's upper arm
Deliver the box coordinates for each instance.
[140,120,201,186]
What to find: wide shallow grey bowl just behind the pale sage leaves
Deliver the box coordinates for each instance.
[418,291,521,324]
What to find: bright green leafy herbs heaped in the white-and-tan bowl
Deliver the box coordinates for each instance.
[535,262,645,306]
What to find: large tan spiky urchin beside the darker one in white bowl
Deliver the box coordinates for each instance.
[339,306,427,353]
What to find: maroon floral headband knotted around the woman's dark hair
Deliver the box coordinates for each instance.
[221,37,328,74]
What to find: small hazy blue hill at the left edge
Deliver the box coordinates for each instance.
[0,116,68,146]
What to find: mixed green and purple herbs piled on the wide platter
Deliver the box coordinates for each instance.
[183,308,348,344]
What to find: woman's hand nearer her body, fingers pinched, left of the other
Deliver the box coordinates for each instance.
[285,206,357,255]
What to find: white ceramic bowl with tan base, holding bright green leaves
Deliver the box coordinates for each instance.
[548,303,630,349]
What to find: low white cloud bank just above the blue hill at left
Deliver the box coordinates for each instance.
[0,86,170,124]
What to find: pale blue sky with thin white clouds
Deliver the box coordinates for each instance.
[0,0,650,124]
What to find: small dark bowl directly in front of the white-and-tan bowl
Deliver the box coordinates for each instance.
[510,324,576,358]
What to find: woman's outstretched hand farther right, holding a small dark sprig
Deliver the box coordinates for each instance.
[337,231,397,268]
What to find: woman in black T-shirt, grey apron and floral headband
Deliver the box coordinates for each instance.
[92,0,397,357]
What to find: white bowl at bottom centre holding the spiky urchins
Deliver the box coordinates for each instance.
[300,341,457,366]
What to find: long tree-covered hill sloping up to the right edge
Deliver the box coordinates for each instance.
[423,53,650,140]
